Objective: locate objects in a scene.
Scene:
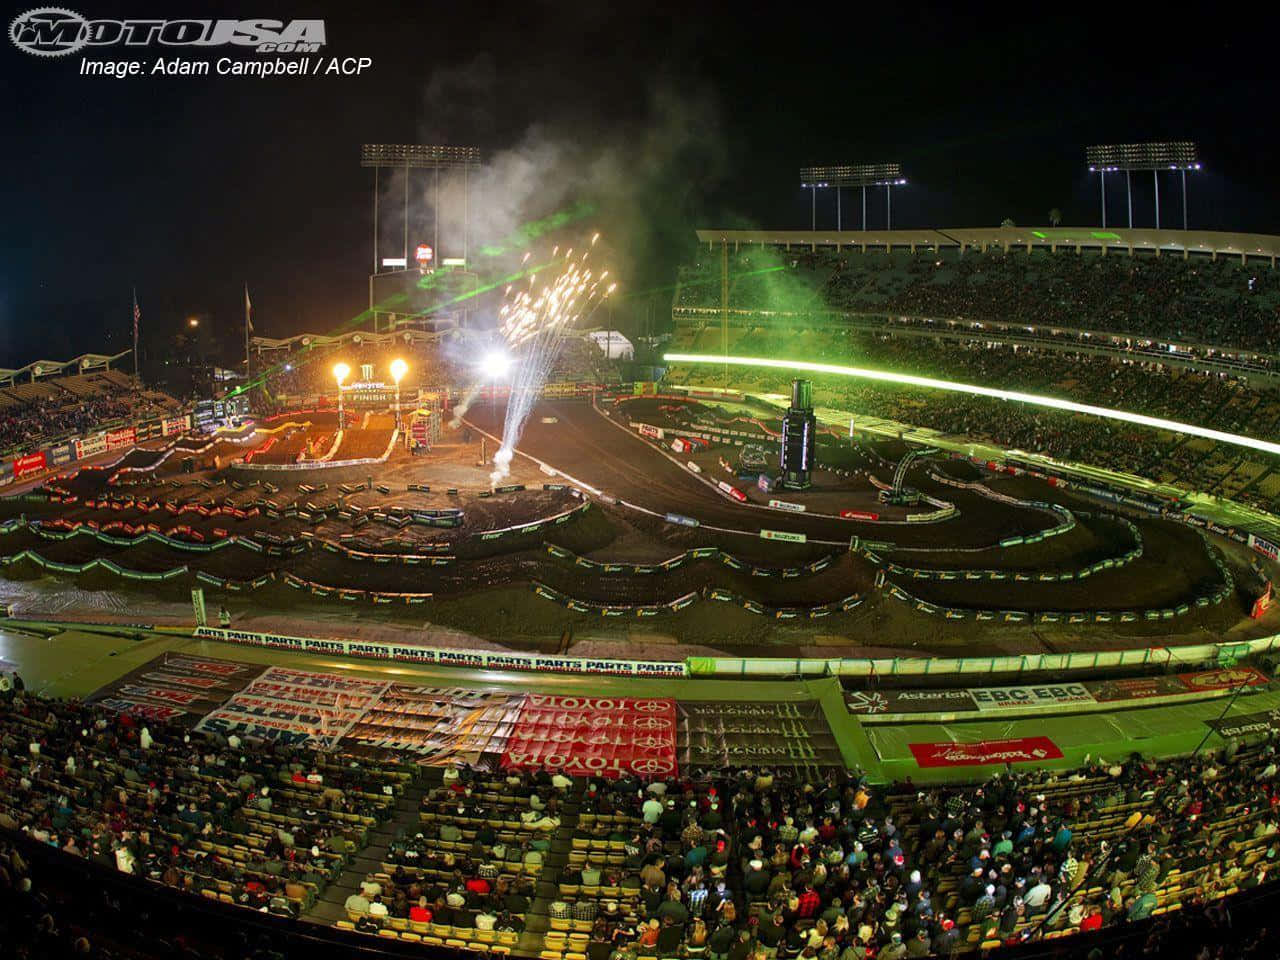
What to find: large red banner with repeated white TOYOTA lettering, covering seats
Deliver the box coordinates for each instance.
[502,694,676,780]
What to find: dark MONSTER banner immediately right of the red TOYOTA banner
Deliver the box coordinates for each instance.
[678,700,844,772]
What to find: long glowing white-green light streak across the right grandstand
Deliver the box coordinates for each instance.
[663,353,1280,454]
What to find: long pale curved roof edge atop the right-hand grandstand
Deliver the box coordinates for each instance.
[698,227,1280,257]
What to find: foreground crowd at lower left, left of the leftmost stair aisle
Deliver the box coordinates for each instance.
[0,692,401,916]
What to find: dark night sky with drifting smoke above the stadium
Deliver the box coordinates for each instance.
[0,0,1280,366]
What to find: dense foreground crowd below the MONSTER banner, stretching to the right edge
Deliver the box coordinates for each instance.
[532,745,1280,960]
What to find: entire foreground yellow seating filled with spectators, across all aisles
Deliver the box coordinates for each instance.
[0,694,1280,960]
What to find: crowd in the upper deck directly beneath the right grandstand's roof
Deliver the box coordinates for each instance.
[677,247,1280,355]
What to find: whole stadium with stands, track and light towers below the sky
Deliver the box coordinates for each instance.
[0,12,1280,960]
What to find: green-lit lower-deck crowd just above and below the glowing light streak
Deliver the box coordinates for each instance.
[671,323,1280,512]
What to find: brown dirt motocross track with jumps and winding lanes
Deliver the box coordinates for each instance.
[0,402,1259,653]
